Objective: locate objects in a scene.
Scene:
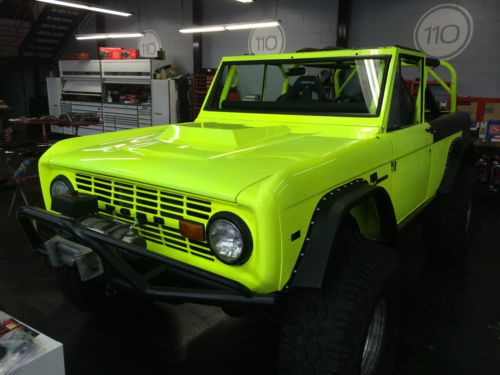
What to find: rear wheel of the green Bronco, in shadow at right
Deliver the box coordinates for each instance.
[423,166,477,263]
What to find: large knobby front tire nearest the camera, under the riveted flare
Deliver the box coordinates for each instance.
[278,235,400,375]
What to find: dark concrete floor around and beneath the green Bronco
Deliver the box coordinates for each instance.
[0,145,500,375]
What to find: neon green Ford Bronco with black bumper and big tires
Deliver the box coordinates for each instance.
[18,47,474,375]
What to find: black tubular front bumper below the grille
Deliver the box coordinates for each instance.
[17,207,276,306]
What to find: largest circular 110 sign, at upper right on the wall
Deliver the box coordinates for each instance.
[413,4,474,60]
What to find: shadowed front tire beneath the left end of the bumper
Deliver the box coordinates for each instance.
[55,266,131,315]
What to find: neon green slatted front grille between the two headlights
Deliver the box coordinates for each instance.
[76,173,215,261]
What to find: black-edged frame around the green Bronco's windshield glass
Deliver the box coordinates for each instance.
[202,54,393,118]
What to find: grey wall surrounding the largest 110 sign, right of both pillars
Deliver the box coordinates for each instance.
[349,0,500,97]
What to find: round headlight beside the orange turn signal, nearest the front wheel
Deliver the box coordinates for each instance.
[207,215,252,264]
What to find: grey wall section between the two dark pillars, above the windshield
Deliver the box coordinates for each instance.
[203,0,338,68]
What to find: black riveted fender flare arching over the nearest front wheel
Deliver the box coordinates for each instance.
[288,180,398,288]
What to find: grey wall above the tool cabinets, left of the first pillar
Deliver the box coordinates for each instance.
[65,0,193,73]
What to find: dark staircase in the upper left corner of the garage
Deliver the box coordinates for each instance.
[18,6,89,61]
